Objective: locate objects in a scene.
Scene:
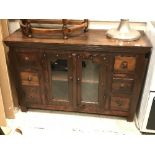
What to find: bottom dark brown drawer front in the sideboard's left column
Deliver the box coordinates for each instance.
[22,86,41,105]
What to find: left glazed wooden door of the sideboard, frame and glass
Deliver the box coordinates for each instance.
[46,51,73,111]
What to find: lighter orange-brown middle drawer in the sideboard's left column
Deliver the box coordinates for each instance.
[20,72,39,86]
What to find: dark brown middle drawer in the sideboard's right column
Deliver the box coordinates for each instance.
[112,78,134,93]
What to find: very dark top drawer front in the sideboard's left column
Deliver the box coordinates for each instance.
[17,52,40,67]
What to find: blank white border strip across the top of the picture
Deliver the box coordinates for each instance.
[0,0,155,21]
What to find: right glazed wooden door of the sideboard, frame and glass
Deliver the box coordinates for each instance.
[77,53,107,113]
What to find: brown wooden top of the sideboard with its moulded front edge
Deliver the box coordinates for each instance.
[4,30,151,50]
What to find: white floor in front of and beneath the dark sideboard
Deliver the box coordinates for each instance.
[7,110,141,135]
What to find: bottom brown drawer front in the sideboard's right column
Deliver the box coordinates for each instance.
[111,96,130,111]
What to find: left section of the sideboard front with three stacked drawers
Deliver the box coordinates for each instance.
[9,48,45,111]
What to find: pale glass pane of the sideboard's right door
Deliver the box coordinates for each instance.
[81,60,99,104]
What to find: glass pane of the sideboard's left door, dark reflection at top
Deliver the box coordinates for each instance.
[51,59,68,100]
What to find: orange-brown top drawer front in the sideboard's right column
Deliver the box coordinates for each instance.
[114,56,136,72]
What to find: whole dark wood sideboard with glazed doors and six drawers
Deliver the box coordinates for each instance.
[4,30,151,121]
